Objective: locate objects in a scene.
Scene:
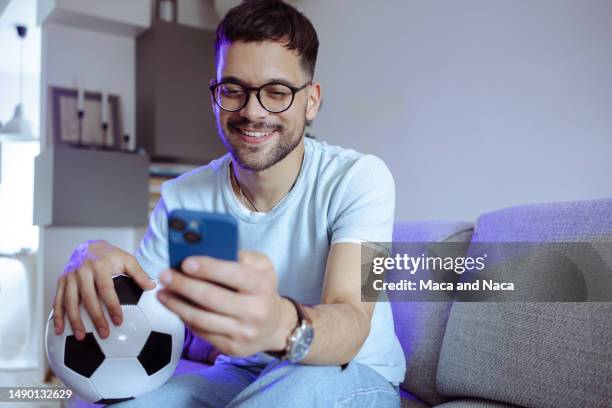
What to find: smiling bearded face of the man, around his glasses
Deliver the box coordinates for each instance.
[212,41,318,171]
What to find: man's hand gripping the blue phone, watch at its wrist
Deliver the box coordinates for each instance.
[158,251,297,356]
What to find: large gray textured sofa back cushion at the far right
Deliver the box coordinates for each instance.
[437,200,612,408]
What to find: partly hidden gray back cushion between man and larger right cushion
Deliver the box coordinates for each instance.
[391,221,473,404]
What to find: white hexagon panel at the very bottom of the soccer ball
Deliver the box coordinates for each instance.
[89,358,149,399]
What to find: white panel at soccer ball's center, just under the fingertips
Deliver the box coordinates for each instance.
[94,305,151,358]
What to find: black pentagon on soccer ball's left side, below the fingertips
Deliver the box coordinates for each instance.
[64,333,105,378]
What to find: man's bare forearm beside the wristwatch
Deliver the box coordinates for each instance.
[274,302,370,365]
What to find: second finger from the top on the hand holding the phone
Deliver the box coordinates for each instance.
[160,269,249,319]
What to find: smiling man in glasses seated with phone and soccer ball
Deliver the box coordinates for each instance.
[54,0,405,407]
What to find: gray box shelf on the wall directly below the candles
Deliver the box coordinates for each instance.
[34,146,149,227]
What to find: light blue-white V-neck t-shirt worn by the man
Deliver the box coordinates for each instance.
[136,138,405,383]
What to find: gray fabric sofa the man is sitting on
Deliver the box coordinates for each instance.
[70,199,612,408]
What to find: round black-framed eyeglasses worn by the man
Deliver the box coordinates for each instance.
[210,80,312,113]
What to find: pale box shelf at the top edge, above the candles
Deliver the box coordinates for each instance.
[38,0,151,37]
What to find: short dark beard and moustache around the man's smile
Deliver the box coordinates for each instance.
[217,112,306,171]
